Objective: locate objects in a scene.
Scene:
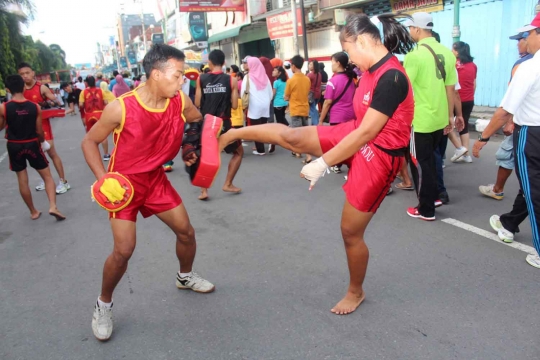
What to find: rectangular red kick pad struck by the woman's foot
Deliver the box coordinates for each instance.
[191,115,223,188]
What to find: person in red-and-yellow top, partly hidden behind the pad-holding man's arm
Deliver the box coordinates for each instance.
[79,76,114,161]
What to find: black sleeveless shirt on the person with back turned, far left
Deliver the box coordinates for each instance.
[4,101,38,141]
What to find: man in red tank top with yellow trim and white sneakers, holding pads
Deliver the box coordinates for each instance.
[82,45,215,340]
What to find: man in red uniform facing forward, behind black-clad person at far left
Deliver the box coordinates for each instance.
[17,63,71,194]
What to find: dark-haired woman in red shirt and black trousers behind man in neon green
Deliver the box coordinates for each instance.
[452,41,478,163]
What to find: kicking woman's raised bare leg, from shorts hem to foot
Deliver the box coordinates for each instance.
[219,124,323,156]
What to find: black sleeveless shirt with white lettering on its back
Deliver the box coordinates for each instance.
[199,72,232,120]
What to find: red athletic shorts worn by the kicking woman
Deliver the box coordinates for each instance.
[317,121,405,213]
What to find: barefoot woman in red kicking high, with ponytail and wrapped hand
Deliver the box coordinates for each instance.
[219,14,414,315]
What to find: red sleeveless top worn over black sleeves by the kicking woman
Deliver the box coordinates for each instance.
[353,56,414,150]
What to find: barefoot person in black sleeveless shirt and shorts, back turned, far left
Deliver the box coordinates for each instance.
[0,75,65,220]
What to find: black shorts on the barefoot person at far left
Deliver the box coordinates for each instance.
[7,140,49,172]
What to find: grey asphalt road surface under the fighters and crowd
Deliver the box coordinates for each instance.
[0,116,540,360]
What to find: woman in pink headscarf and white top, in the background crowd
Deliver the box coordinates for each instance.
[240,56,273,155]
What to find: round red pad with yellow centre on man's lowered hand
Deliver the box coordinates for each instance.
[91,172,134,212]
